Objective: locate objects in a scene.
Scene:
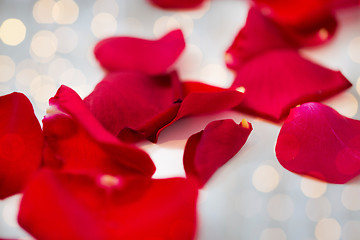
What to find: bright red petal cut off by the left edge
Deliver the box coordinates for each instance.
[0,93,43,199]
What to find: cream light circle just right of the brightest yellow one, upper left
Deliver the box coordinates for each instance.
[30,31,58,59]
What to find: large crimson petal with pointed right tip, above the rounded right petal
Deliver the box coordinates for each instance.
[232,50,351,121]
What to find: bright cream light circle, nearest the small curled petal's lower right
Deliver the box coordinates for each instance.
[252,165,279,192]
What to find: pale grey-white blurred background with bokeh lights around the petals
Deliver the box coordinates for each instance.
[0,0,360,240]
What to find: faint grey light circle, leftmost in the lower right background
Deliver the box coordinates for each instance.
[235,190,263,218]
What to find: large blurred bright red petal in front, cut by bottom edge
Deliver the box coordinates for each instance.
[18,171,197,240]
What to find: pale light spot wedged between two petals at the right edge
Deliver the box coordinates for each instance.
[323,91,358,118]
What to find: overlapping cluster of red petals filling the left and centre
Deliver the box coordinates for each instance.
[0,31,252,240]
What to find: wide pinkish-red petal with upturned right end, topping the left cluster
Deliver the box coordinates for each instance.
[94,29,185,75]
